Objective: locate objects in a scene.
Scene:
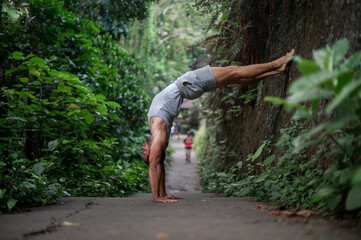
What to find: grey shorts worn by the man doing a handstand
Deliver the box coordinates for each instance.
[175,66,216,100]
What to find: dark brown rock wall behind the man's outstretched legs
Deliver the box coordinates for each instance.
[205,0,361,168]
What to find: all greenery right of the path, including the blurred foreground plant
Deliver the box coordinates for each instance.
[196,40,361,216]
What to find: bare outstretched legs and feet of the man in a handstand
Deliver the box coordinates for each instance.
[212,49,295,88]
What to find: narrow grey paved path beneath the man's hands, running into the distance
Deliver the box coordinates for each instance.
[0,136,361,240]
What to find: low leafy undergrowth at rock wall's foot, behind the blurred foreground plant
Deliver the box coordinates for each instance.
[197,122,322,207]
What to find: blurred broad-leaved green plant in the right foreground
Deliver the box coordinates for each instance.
[265,39,361,214]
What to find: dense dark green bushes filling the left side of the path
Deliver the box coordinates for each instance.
[0,0,149,210]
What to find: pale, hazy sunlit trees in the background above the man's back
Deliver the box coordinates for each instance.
[120,0,207,96]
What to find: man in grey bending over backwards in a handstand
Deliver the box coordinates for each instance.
[142,49,295,203]
